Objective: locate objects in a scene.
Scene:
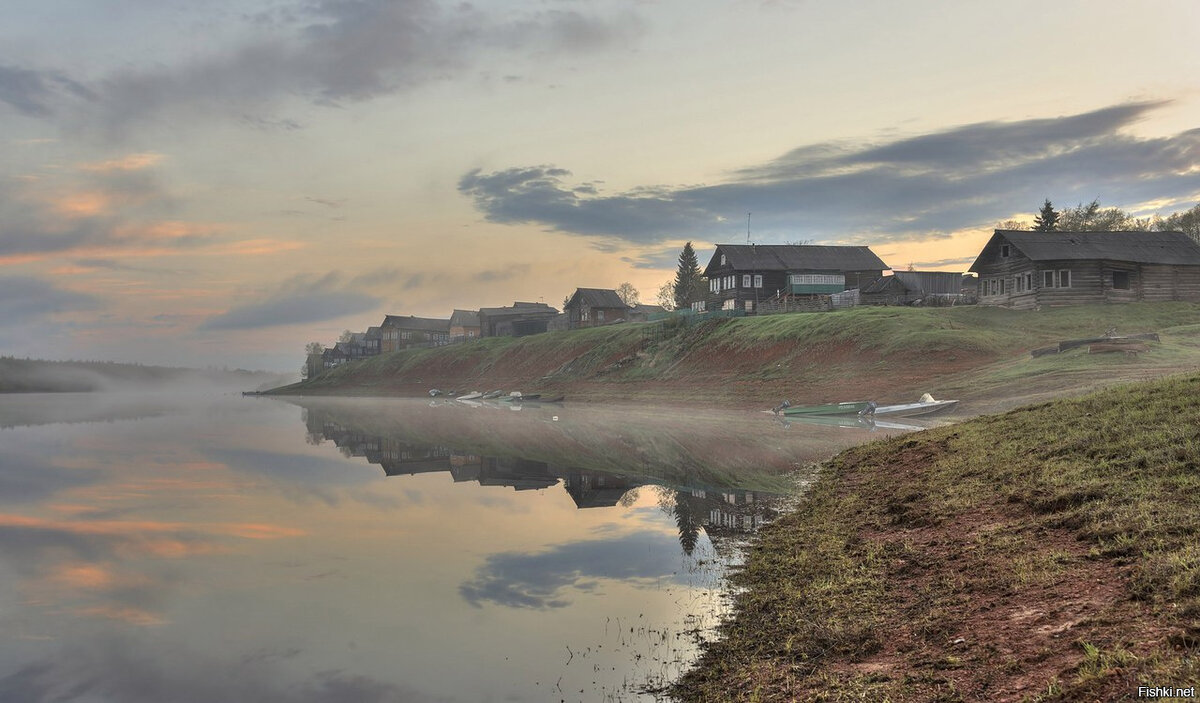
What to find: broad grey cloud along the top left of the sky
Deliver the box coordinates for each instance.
[7,0,642,137]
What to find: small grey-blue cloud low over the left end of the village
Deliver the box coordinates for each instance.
[199,272,382,330]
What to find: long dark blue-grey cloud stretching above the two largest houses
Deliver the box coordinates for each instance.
[458,102,1200,248]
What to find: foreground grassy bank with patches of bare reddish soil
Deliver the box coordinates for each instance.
[673,374,1200,702]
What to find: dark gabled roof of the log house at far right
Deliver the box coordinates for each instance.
[970,229,1200,271]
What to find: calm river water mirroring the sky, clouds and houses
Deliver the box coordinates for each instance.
[0,393,907,703]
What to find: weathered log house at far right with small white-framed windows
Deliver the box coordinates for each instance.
[971,229,1200,310]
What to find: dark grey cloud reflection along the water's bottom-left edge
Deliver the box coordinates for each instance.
[0,637,452,703]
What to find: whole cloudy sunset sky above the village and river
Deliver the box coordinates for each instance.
[0,0,1200,371]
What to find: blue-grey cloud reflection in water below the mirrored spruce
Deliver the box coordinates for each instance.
[458,530,686,609]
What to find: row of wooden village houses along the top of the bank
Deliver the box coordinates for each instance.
[307,229,1200,375]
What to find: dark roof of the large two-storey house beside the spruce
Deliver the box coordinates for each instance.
[704,244,888,275]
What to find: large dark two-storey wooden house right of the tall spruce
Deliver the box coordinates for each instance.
[704,244,888,313]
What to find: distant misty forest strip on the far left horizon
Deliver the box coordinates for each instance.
[0,356,293,393]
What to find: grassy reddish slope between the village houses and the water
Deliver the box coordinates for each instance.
[272,304,1200,414]
